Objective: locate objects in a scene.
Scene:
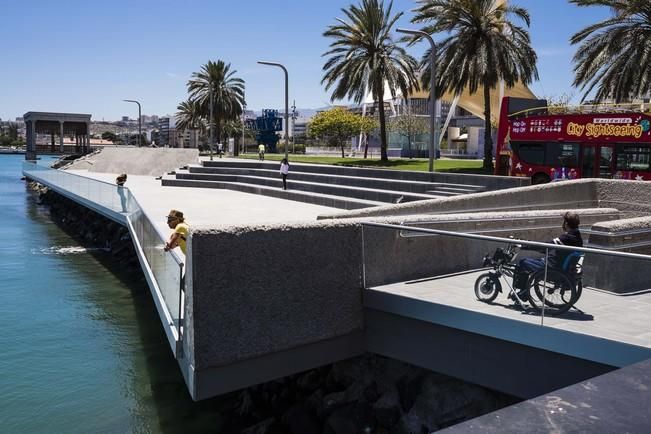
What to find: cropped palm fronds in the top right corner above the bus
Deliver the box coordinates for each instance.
[570,0,651,102]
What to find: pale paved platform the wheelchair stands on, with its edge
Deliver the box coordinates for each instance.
[367,271,651,366]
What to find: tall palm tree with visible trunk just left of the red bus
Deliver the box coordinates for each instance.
[412,0,538,170]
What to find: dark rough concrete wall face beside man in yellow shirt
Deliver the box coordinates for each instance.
[187,222,363,370]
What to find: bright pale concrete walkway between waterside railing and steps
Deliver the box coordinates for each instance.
[69,170,334,236]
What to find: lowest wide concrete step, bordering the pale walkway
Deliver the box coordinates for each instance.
[161,176,386,209]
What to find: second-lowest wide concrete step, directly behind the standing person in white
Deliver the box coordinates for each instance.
[176,170,438,203]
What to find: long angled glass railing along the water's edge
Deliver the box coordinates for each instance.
[23,161,184,349]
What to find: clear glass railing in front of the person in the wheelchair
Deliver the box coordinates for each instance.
[362,223,651,334]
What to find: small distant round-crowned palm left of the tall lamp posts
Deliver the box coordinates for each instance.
[188,60,244,141]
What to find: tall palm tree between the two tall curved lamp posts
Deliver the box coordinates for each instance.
[321,0,418,161]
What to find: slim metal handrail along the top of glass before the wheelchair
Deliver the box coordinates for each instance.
[361,222,651,261]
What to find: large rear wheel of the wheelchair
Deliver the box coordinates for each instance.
[528,270,577,315]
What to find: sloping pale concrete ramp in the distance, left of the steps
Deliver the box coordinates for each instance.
[66,146,199,176]
